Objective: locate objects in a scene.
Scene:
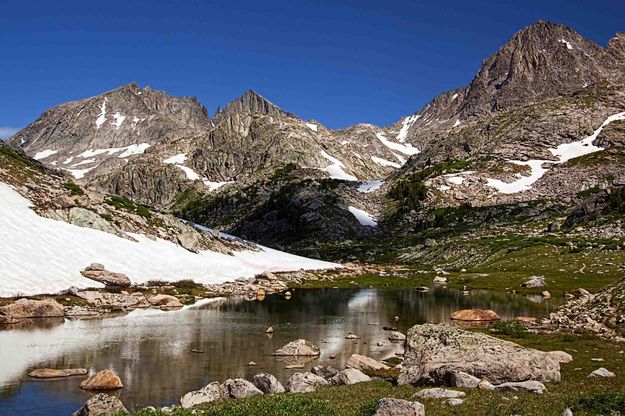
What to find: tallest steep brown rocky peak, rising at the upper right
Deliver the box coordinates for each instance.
[461,20,625,118]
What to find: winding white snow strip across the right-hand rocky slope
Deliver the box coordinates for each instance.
[487,111,625,194]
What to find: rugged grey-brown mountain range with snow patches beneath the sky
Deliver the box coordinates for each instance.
[8,21,625,256]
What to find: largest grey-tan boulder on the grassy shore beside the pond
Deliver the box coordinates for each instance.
[398,324,560,384]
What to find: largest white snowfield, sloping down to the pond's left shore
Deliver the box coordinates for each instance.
[0,182,340,297]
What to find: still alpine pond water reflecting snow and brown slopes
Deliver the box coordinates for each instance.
[0,289,560,416]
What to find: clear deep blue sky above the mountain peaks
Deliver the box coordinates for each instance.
[0,0,625,135]
